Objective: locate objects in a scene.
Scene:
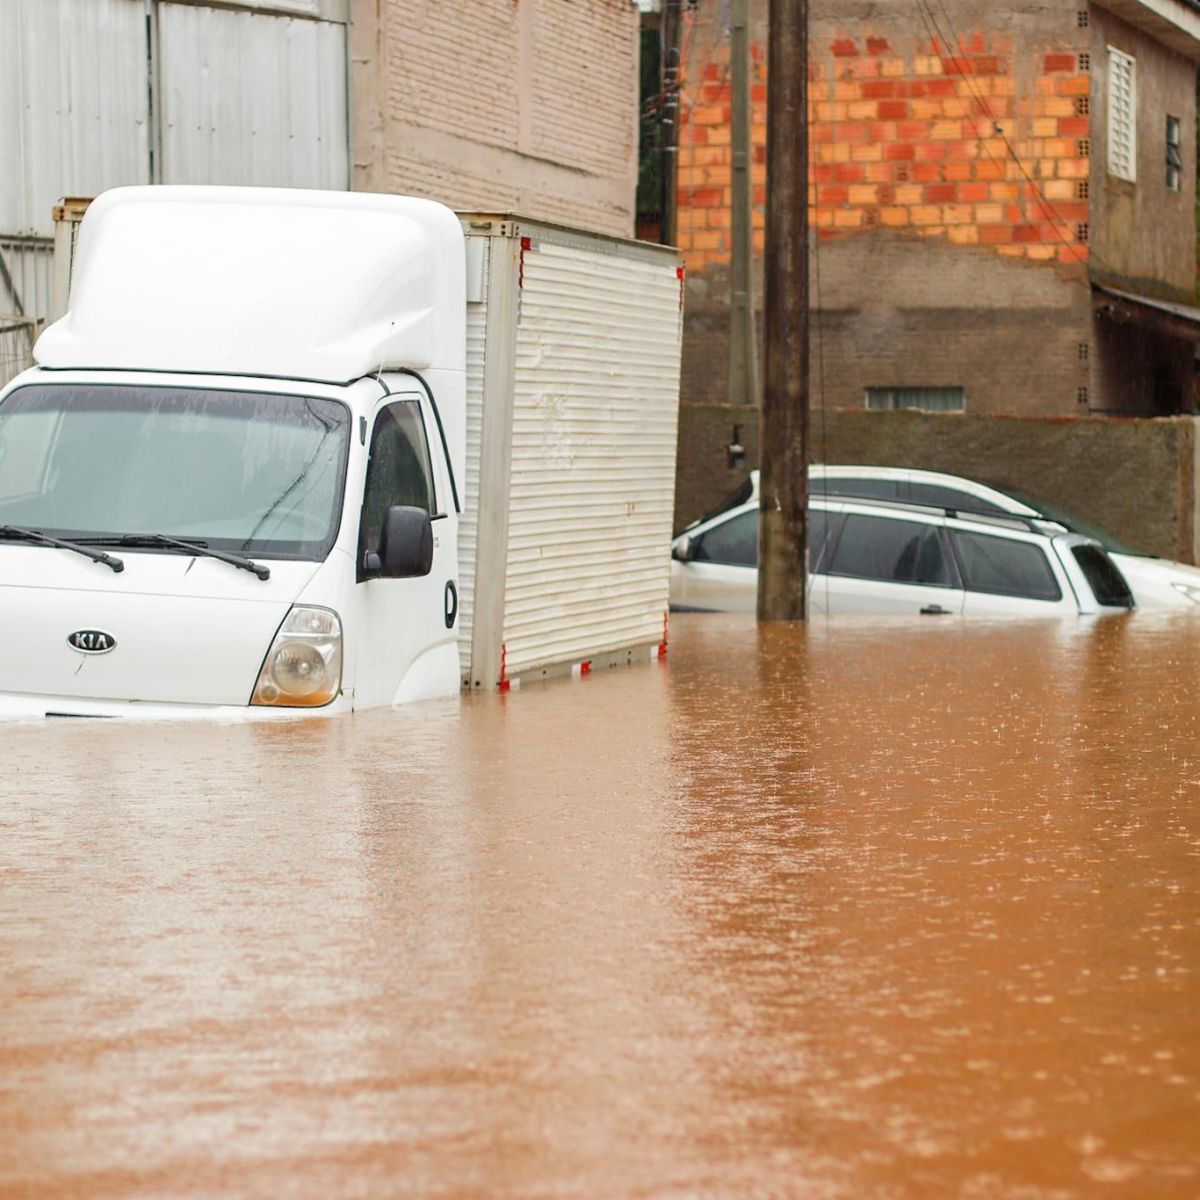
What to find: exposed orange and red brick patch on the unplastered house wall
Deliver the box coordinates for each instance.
[679,23,1091,271]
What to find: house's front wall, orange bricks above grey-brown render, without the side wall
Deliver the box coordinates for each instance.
[679,0,1097,415]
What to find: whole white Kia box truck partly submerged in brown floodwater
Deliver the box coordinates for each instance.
[0,187,682,718]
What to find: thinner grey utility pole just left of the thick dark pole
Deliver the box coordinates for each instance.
[728,0,758,406]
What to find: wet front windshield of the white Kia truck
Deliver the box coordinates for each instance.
[0,383,350,560]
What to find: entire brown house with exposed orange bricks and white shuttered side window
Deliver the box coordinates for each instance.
[677,0,1200,422]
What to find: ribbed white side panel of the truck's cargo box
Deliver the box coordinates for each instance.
[504,229,680,677]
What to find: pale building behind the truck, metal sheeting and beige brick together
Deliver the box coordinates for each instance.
[0,0,640,382]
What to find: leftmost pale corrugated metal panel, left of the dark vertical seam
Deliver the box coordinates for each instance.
[0,0,149,236]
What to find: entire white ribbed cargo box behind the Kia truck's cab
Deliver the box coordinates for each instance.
[460,214,683,688]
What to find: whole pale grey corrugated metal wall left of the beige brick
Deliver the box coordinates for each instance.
[0,0,349,383]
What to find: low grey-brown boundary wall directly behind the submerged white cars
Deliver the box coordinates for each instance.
[676,404,1196,562]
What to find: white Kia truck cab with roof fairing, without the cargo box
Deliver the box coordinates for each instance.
[0,188,464,718]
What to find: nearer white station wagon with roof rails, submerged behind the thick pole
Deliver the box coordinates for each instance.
[671,468,1134,616]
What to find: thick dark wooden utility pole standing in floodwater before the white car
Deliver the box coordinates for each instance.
[758,0,809,620]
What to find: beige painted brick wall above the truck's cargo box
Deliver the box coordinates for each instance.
[350,0,638,236]
